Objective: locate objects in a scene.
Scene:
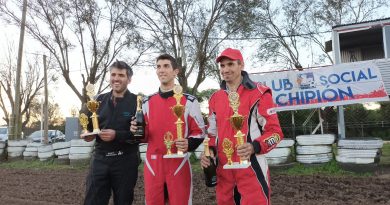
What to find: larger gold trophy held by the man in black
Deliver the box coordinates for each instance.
[80,84,100,138]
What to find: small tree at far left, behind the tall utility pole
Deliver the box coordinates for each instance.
[0,43,56,127]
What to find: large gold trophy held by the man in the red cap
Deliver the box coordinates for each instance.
[224,92,251,169]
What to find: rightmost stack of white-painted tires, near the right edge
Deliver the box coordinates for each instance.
[336,138,383,171]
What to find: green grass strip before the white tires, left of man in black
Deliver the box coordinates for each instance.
[0,160,88,171]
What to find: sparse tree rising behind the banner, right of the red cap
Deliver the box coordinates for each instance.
[251,0,389,69]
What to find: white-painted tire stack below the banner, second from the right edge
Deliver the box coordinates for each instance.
[296,134,335,164]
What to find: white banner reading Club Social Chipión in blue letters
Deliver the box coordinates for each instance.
[250,61,389,111]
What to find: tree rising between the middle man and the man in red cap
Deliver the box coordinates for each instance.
[131,0,261,94]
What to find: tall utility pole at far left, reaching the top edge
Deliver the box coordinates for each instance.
[9,0,27,140]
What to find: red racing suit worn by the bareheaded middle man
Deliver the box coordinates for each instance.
[142,91,205,205]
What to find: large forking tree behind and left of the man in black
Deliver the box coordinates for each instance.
[0,0,148,110]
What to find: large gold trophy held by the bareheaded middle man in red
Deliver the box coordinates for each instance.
[163,85,187,158]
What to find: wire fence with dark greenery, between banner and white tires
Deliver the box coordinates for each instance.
[278,102,390,140]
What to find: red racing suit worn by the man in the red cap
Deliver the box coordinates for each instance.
[207,71,283,205]
